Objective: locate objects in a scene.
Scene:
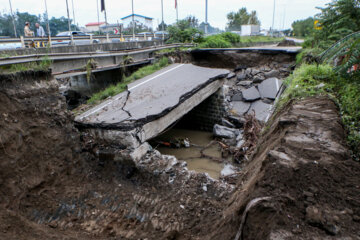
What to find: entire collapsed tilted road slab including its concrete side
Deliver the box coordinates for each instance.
[75,64,229,149]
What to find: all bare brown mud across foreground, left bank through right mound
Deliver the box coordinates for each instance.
[0,55,360,240]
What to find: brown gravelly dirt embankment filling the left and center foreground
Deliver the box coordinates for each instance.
[0,72,232,239]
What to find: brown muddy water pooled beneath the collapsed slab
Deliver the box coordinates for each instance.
[153,129,225,179]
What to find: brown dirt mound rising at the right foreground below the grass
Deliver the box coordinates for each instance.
[209,98,360,239]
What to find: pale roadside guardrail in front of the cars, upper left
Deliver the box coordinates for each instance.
[0,33,165,48]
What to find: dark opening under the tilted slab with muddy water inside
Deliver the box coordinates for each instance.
[150,90,239,179]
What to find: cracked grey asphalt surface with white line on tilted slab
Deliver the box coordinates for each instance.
[75,64,229,129]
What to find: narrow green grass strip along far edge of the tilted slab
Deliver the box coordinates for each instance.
[87,57,169,104]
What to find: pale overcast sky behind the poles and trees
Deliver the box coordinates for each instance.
[0,0,330,29]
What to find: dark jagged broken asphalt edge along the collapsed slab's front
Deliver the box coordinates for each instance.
[74,71,230,131]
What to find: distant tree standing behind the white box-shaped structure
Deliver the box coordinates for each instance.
[227,8,260,31]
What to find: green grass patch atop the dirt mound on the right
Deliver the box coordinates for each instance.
[276,64,360,160]
